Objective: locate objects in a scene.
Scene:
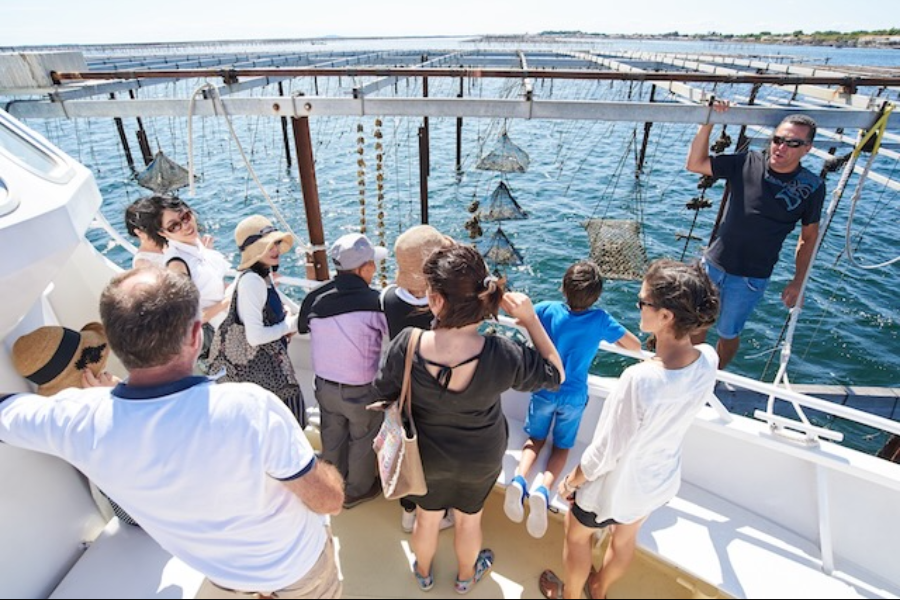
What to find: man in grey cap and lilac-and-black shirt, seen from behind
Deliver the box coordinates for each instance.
[297,233,388,508]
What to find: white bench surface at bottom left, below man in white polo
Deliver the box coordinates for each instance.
[50,518,203,598]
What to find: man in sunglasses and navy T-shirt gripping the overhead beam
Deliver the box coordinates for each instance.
[687,102,825,369]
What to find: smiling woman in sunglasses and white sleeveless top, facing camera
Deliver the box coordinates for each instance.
[149,196,231,359]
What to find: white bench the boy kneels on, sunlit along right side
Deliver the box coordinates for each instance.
[497,397,865,598]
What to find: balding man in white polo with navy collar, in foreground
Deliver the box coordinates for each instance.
[0,266,344,598]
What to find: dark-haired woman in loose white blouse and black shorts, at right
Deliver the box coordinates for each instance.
[539,259,719,598]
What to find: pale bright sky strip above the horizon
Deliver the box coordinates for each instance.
[0,0,900,46]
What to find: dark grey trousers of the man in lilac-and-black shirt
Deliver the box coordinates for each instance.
[316,377,384,499]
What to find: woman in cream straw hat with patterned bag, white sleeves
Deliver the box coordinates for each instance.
[209,215,306,426]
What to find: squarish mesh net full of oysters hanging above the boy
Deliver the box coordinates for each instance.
[584,219,647,280]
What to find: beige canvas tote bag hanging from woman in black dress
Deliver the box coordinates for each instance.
[372,329,428,500]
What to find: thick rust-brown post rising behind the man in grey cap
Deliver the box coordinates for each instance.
[291,117,328,281]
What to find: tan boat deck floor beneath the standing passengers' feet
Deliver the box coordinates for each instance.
[333,488,728,598]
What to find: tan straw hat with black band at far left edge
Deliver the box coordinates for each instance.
[12,322,109,396]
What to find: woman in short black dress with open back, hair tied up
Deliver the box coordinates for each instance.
[375,244,565,594]
